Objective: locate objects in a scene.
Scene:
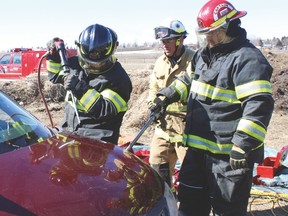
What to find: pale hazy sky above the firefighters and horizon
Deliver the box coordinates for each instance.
[0,0,288,51]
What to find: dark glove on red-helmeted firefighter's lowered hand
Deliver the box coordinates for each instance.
[230,145,248,170]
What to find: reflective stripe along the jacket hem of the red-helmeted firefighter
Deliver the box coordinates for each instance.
[183,134,233,154]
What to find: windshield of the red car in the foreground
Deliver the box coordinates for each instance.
[0,91,53,153]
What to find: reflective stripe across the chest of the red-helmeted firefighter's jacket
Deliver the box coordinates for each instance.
[191,80,240,103]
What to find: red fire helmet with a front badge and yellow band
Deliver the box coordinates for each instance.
[196,0,247,33]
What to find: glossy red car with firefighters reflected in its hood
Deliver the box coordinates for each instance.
[0,91,177,216]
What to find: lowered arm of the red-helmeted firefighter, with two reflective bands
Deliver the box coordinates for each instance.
[230,66,274,168]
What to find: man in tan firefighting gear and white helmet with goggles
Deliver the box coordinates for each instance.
[148,19,194,192]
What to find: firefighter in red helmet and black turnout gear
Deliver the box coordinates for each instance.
[152,0,274,216]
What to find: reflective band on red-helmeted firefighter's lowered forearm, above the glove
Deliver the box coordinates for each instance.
[237,119,266,142]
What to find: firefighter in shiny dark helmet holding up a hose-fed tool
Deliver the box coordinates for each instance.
[46,24,132,144]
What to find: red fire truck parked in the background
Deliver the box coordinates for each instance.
[0,48,76,79]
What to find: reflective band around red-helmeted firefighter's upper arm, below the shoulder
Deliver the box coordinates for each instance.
[235,80,272,99]
